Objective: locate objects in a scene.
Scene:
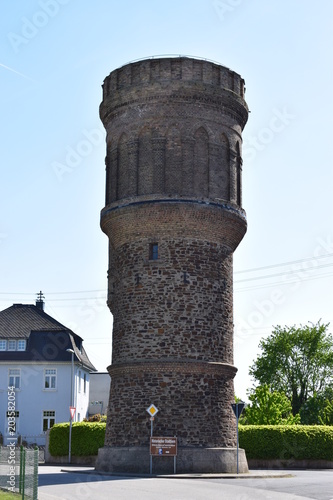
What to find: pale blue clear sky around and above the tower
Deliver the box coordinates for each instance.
[0,0,333,398]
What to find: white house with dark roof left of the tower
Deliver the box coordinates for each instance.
[0,299,96,445]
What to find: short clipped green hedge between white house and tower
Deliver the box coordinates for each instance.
[49,422,106,457]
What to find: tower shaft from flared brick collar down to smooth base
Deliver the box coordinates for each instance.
[103,199,246,447]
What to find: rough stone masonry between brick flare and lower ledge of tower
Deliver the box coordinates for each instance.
[109,239,233,363]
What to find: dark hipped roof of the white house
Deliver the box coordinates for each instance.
[0,304,96,371]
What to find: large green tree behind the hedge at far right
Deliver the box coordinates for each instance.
[250,321,333,415]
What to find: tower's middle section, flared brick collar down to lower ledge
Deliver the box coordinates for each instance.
[103,203,246,364]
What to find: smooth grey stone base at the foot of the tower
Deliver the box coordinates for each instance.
[96,446,249,474]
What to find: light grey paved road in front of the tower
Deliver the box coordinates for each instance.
[38,466,333,500]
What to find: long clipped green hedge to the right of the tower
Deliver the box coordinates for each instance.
[239,425,333,461]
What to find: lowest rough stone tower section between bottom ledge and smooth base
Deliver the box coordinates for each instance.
[105,362,236,448]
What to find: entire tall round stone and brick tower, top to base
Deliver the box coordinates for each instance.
[97,57,248,472]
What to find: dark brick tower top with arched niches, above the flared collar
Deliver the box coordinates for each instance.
[100,57,248,211]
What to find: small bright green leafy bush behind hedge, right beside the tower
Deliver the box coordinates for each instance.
[240,384,300,425]
